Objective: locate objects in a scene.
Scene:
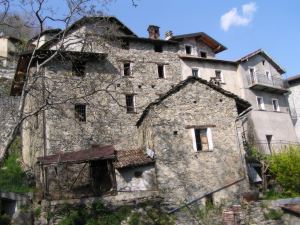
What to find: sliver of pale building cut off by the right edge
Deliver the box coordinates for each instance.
[287,75,300,142]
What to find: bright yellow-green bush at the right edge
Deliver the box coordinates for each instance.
[267,146,300,194]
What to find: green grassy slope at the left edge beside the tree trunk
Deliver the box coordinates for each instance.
[0,138,32,193]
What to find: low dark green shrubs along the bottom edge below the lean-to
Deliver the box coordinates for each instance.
[56,202,174,225]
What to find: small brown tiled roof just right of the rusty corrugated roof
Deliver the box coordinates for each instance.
[115,149,154,169]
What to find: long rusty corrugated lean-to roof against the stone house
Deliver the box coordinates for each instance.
[37,145,115,165]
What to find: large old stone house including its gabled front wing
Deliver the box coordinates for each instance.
[11,17,296,205]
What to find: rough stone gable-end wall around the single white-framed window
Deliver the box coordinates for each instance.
[139,82,247,207]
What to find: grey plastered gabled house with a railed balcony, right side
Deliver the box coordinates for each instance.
[238,49,297,153]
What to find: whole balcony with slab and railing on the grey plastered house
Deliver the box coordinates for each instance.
[247,74,289,94]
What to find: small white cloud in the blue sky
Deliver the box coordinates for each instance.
[220,2,256,31]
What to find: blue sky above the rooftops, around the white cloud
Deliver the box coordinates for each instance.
[107,0,300,76]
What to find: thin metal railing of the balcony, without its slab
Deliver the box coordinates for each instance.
[247,74,288,90]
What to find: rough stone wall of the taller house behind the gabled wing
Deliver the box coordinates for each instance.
[24,28,181,167]
